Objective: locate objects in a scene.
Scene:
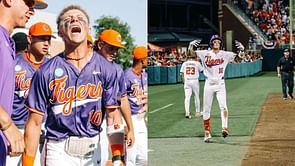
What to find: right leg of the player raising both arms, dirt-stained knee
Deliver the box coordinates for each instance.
[216,84,228,138]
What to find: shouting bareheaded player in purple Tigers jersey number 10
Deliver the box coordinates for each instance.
[22,5,122,166]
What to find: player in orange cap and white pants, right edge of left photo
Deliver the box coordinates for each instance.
[124,46,148,166]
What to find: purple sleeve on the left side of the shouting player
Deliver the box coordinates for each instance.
[26,70,49,115]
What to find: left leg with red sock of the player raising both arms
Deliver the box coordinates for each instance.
[203,81,215,142]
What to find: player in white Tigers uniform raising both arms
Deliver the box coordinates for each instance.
[189,35,244,142]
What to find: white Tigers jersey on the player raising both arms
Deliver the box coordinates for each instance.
[196,50,237,80]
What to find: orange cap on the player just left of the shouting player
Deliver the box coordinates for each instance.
[29,22,56,38]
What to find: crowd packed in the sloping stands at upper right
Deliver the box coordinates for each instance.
[236,0,295,47]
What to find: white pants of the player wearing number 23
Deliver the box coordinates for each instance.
[184,80,200,114]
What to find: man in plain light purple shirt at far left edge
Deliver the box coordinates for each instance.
[0,0,43,166]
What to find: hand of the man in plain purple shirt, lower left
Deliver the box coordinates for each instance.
[3,123,25,157]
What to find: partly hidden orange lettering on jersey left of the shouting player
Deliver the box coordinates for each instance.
[15,71,32,97]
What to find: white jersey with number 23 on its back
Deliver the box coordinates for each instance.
[180,60,203,82]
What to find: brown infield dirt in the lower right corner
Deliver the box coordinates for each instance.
[242,93,295,166]
